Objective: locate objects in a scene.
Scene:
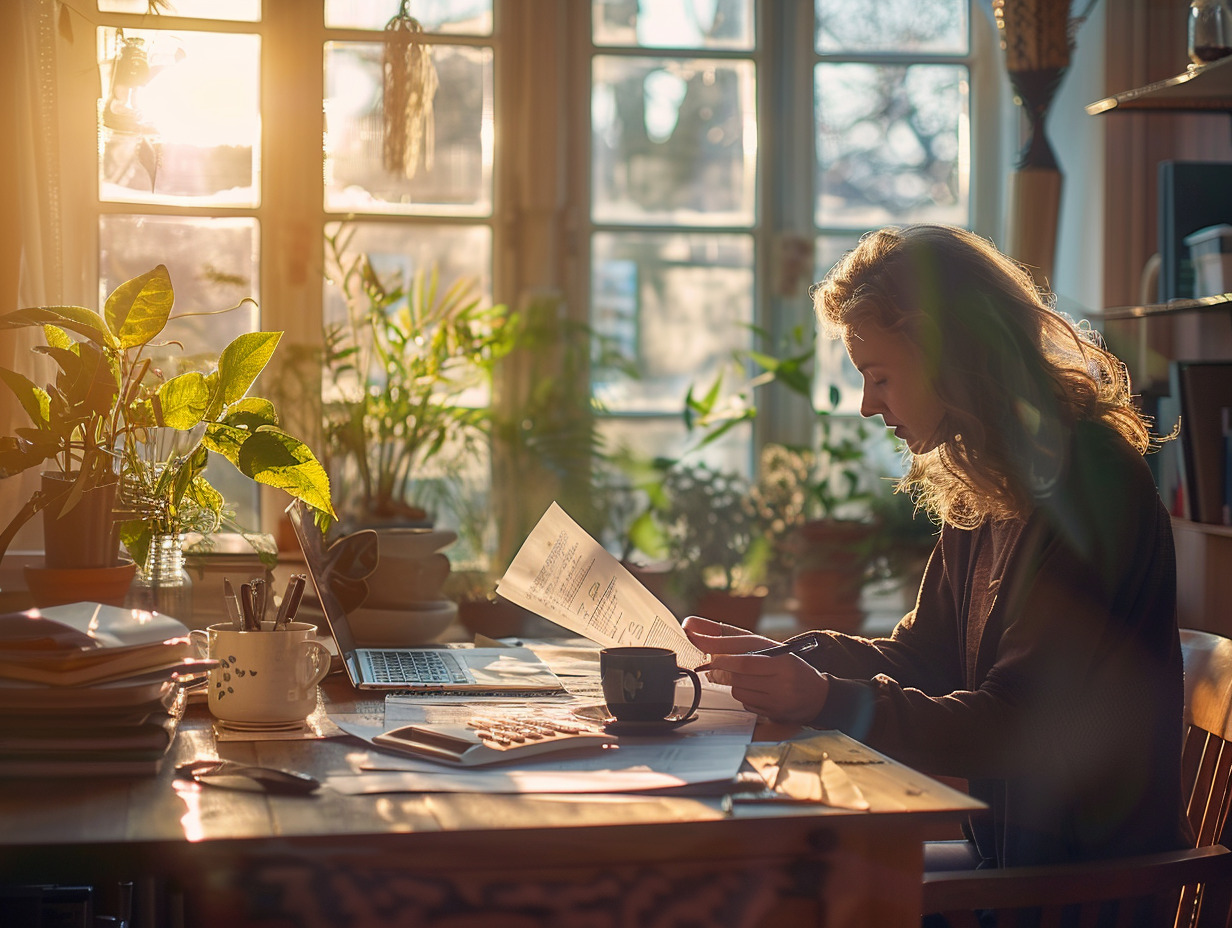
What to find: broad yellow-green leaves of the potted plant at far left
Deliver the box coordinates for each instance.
[0,265,334,563]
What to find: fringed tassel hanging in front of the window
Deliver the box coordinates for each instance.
[384,0,437,177]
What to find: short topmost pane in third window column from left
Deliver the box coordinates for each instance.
[591,0,753,48]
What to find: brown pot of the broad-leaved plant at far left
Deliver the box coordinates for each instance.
[42,473,120,569]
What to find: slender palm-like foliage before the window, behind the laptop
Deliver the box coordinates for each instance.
[324,232,513,523]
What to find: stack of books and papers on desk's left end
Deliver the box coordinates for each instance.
[0,603,213,776]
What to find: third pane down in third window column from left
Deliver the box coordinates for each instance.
[590,233,753,414]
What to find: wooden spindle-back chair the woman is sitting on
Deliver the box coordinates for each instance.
[923,629,1232,928]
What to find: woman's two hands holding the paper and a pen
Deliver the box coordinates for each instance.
[684,615,829,725]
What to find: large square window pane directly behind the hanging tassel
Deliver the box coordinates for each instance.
[325,42,493,216]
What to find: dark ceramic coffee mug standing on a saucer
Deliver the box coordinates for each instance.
[599,647,701,723]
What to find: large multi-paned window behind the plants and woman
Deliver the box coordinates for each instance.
[33,0,999,549]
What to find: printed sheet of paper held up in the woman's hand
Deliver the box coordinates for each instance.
[496,503,705,669]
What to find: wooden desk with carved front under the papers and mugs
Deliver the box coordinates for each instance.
[0,660,982,928]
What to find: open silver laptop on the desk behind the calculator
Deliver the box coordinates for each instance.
[287,500,567,696]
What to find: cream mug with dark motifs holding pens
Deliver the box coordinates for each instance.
[190,621,330,725]
